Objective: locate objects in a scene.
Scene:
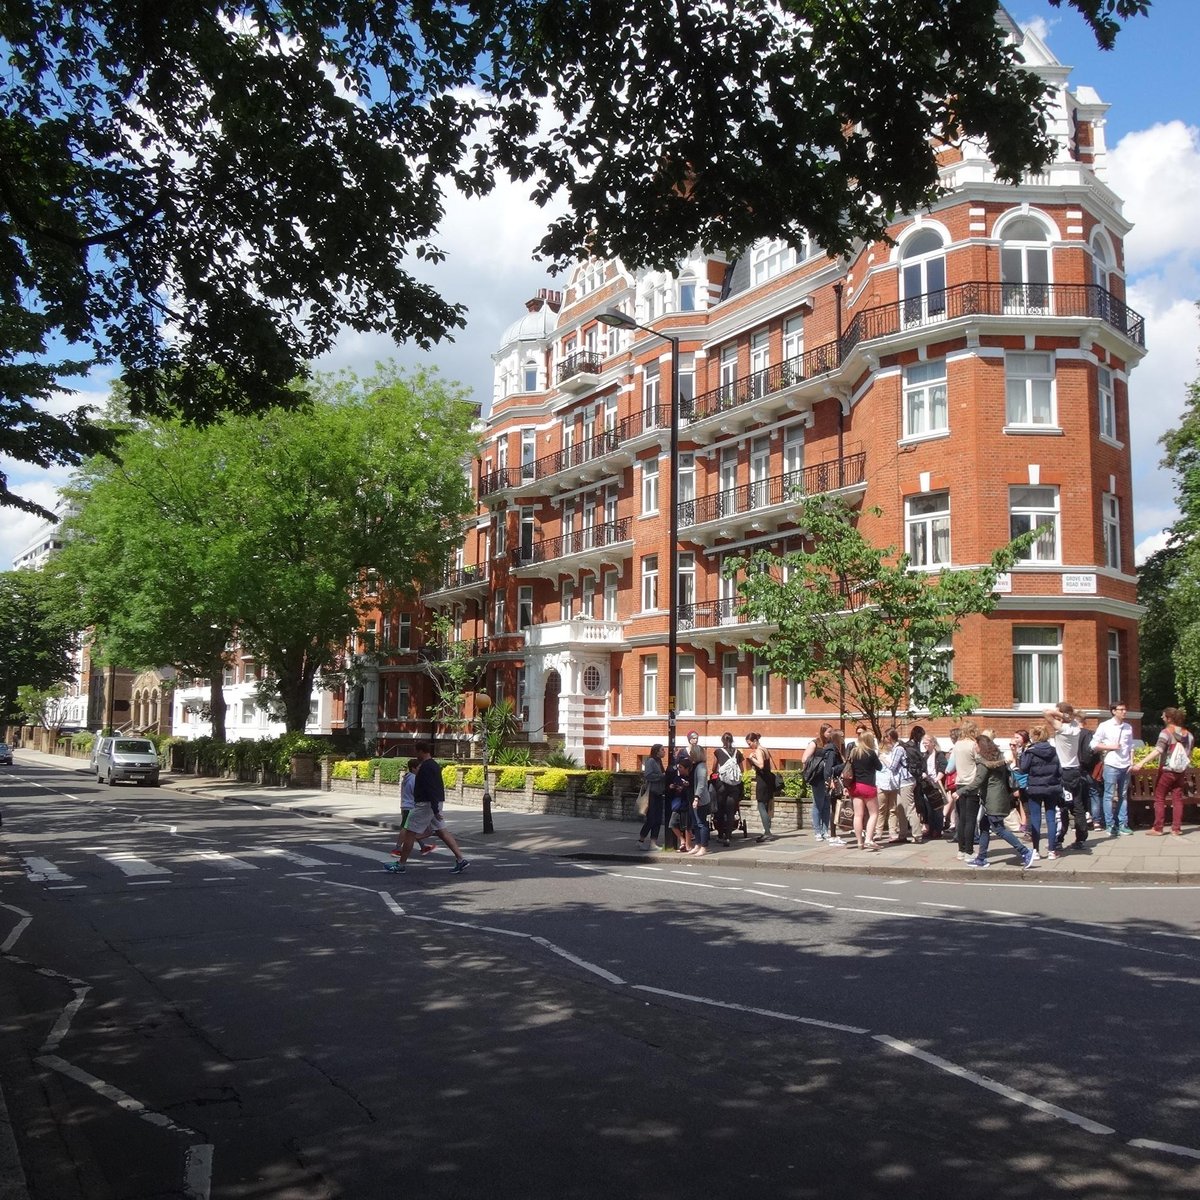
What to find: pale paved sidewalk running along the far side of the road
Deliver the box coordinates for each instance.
[17,750,1200,884]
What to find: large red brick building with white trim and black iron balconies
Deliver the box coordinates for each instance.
[367,21,1145,767]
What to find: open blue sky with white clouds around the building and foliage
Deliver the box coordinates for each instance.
[0,0,1200,569]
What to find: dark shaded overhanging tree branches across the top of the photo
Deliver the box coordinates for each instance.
[0,0,1148,504]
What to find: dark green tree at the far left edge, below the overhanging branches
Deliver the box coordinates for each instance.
[0,570,76,720]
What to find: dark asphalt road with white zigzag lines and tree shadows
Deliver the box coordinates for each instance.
[0,767,1200,1200]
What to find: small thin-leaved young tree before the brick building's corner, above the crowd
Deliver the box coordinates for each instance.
[728,497,1033,734]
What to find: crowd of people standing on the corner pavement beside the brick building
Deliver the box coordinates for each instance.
[637,703,1195,868]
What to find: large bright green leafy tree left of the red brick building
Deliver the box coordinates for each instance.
[64,367,476,731]
